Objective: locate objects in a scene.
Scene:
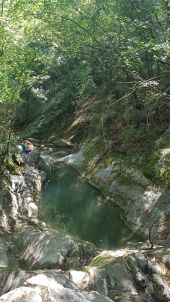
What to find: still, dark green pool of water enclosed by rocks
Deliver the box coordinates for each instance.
[42,164,137,249]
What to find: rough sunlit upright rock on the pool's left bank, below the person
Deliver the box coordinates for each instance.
[0,166,41,231]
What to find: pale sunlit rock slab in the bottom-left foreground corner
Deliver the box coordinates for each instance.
[0,271,111,302]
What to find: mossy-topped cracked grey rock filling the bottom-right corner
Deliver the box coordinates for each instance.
[82,250,170,302]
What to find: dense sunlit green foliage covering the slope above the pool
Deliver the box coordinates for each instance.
[0,0,170,182]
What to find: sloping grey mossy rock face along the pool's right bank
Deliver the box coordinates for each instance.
[92,162,170,240]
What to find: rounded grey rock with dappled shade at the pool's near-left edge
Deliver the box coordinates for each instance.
[15,227,97,269]
